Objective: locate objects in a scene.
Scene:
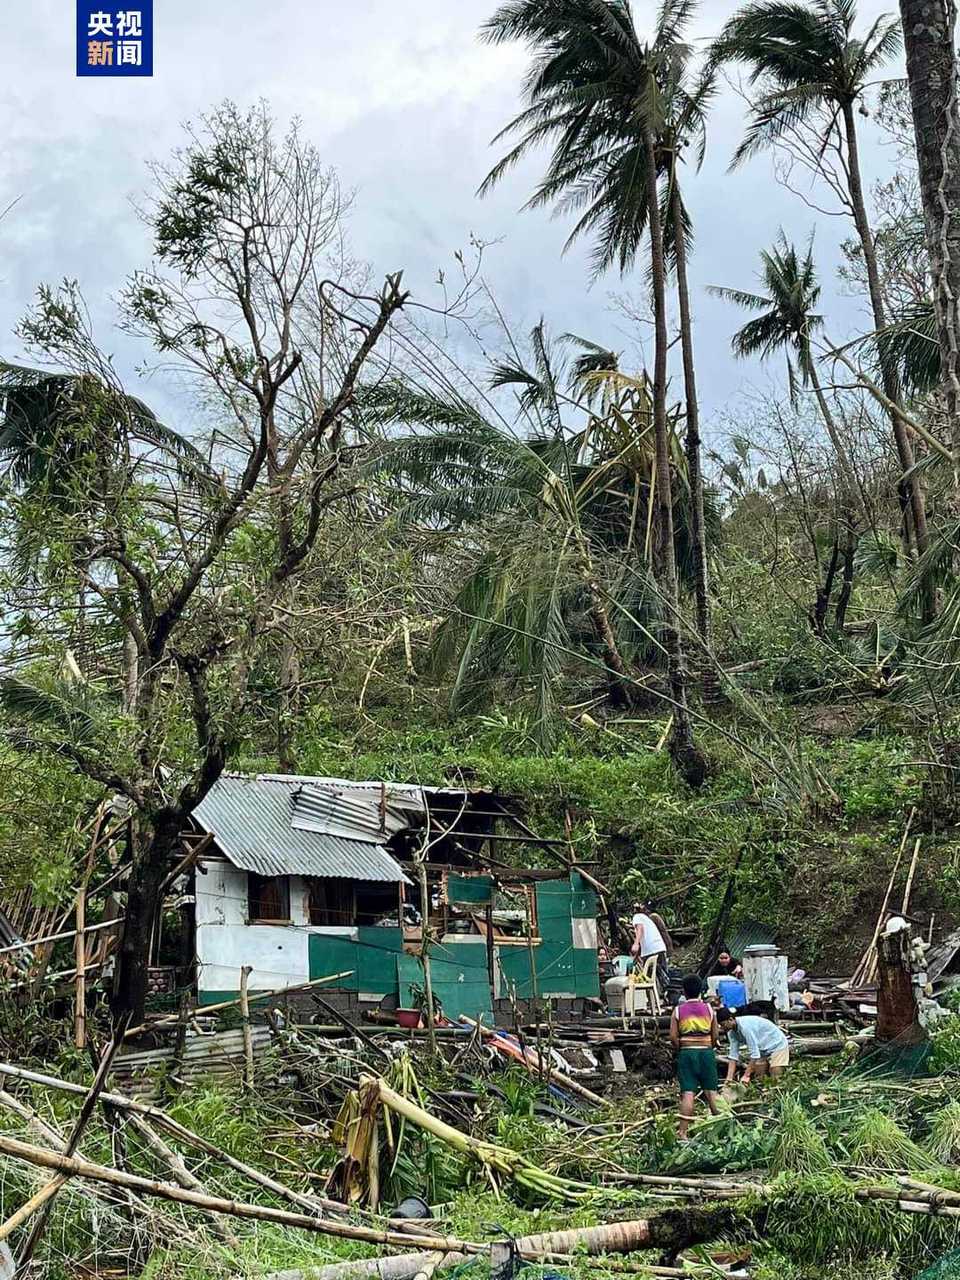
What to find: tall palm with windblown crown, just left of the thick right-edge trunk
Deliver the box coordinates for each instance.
[712,0,928,588]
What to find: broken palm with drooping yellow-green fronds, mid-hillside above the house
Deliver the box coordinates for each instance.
[362,326,719,746]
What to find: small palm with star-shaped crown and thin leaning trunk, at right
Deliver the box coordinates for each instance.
[710,232,863,630]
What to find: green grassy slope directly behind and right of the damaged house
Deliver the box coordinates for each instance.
[280,708,960,973]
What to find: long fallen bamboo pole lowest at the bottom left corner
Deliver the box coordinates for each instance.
[0,1134,468,1253]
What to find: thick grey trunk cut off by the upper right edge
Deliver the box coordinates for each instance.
[900,0,960,453]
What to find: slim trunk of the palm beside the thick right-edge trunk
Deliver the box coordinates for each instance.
[842,102,934,622]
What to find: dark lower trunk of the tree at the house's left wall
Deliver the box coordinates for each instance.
[110,810,182,1025]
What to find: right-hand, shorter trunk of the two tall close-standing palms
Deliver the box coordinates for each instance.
[671,175,716,676]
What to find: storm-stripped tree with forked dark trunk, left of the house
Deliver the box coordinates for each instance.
[4,104,406,1018]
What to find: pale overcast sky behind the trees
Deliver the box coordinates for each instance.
[0,0,911,435]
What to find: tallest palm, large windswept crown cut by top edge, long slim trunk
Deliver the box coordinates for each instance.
[481,0,707,785]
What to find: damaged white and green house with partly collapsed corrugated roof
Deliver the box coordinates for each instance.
[184,774,599,1024]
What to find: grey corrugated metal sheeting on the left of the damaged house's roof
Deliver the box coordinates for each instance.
[193,773,410,884]
